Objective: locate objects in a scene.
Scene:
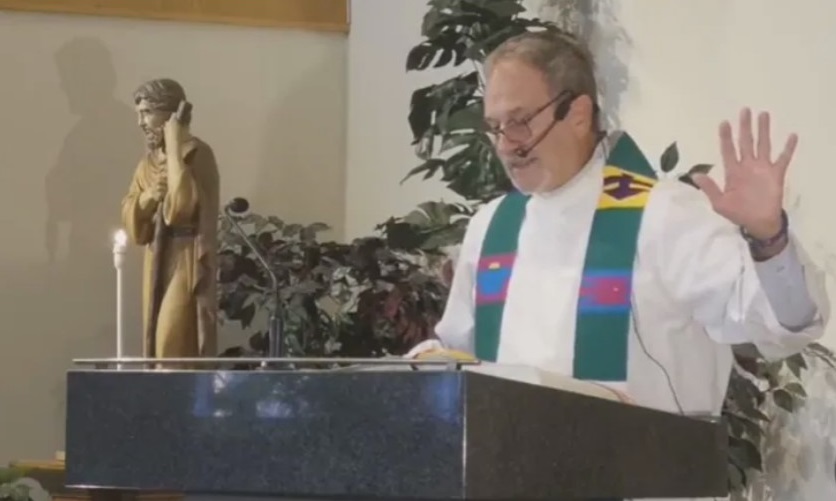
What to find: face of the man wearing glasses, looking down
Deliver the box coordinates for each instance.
[484,59,572,193]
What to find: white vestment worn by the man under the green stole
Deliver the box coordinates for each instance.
[424,141,828,500]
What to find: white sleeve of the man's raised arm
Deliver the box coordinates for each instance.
[642,181,829,358]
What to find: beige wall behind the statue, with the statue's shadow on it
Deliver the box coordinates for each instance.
[0,12,346,461]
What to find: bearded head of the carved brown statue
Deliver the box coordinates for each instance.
[133,78,192,150]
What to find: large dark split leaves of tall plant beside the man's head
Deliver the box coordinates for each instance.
[405,0,557,202]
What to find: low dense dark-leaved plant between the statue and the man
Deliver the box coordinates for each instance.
[218,214,446,357]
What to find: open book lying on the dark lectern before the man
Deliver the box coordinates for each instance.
[415,349,632,403]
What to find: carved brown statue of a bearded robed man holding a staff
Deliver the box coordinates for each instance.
[122,79,219,358]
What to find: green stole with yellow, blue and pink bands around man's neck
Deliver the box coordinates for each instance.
[475,133,657,382]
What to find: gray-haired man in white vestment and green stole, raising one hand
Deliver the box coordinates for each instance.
[412,33,827,496]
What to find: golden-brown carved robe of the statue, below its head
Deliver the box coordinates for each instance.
[122,137,220,358]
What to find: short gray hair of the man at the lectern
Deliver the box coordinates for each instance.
[485,30,598,109]
